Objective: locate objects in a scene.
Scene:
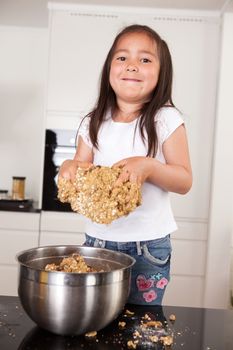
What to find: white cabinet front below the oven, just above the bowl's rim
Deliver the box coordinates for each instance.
[39,211,85,246]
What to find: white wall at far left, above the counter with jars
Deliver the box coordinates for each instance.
[0,26,48,201]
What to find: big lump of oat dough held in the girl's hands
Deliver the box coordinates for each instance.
[58,166,141,224]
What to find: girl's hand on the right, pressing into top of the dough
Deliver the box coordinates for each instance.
[113,157,150,186]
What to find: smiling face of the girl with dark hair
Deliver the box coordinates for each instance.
[109,33,160,104]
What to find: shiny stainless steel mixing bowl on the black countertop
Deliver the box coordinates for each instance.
[17,245,135,335]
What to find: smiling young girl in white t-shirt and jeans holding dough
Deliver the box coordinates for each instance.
[59,25,192,305]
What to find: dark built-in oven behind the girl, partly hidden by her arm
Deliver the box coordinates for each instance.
[42,129,76,211]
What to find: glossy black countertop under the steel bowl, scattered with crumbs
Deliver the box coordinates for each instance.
[0,296,233,350]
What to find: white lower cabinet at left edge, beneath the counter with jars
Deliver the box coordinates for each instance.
[0,211,40,295]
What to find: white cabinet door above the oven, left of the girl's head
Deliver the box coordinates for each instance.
[48,11,119,112]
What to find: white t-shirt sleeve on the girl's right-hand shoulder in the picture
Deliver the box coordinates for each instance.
[156,107,184,144]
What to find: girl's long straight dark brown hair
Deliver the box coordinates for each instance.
[81,24,174,157]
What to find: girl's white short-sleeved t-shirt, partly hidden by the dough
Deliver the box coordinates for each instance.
[79,107,184,242]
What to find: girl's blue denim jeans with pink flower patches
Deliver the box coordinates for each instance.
[84,235,172,305]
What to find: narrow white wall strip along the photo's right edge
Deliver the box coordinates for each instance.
[205,13,233,307]
